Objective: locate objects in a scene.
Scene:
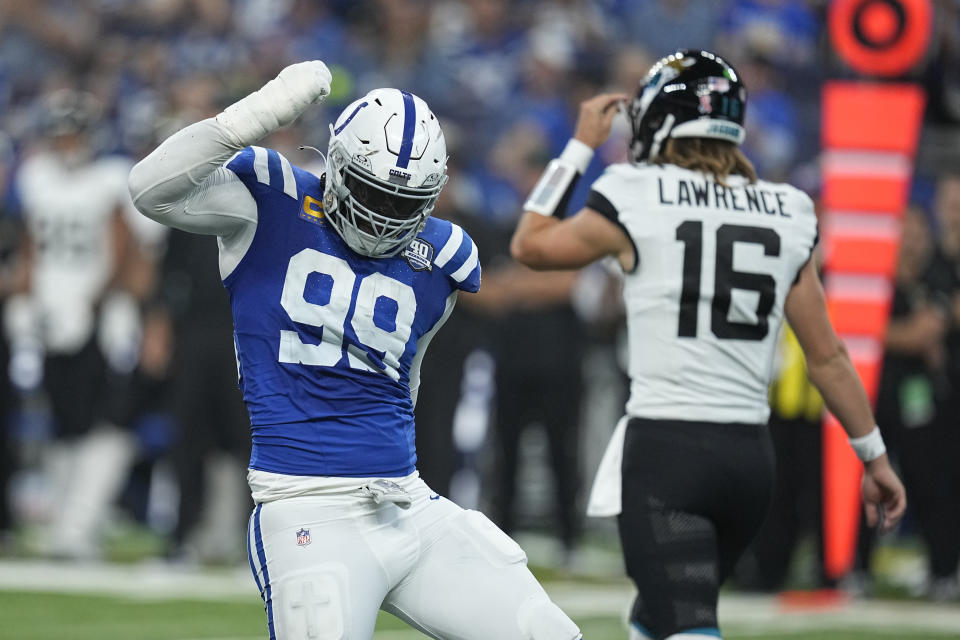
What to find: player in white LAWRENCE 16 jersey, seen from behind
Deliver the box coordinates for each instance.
[512,51,906,640]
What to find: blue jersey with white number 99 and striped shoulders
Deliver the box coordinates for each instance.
[224,147,480,477]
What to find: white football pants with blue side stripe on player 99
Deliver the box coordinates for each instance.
[247,477,580,640]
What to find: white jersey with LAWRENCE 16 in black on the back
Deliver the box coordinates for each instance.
[589,164,817,423]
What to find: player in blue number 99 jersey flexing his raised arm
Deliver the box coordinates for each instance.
[130,61,580,640]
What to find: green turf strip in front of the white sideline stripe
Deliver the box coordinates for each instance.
[0,591,960,640]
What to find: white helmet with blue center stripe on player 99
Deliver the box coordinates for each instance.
[323,89,447,258]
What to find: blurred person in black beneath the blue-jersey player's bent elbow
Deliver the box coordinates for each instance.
[157,230,251,562]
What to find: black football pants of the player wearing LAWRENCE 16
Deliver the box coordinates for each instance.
[619,418,774,640]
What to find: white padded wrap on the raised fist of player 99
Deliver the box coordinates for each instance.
[217,60,331,148]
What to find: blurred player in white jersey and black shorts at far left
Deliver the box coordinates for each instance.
[5,89,165,558]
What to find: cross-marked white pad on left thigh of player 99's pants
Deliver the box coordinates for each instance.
[272,563,350,640]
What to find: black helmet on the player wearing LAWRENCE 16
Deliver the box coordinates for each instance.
[628,49,747,162]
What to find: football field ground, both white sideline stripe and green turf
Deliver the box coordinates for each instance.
[0,559,960,640]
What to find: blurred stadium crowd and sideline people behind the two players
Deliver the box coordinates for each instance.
[0,0,960,599]
